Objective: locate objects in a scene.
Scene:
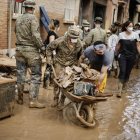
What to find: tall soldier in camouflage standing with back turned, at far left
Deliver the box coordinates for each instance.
[15,0,45,108]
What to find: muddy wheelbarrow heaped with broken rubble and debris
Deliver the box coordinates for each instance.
[52,63,107,127]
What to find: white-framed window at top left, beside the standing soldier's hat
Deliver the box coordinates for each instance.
[12,0,24,19]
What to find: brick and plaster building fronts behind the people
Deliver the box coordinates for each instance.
[0,0,139,52]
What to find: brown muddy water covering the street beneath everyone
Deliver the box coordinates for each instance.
[0,70,140,140]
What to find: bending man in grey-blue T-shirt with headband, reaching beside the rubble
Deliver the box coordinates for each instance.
[80,41,111,96]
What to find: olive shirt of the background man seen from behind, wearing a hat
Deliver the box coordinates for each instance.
[84,28,107,46]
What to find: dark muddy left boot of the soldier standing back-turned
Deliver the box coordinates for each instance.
[17,84,24,105]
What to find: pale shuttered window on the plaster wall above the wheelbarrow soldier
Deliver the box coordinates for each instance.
[64,0,76,23]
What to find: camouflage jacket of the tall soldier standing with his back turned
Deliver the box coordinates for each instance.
[15,13,43,51]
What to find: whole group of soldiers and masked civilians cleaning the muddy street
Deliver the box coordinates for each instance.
[15,0,140,108]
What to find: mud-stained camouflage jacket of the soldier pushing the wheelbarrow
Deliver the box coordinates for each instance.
[46,36,83,66]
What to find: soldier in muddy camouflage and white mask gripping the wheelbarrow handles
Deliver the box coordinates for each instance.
[46,26,82,107]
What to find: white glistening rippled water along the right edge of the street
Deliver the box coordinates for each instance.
[114,77,140,140]
